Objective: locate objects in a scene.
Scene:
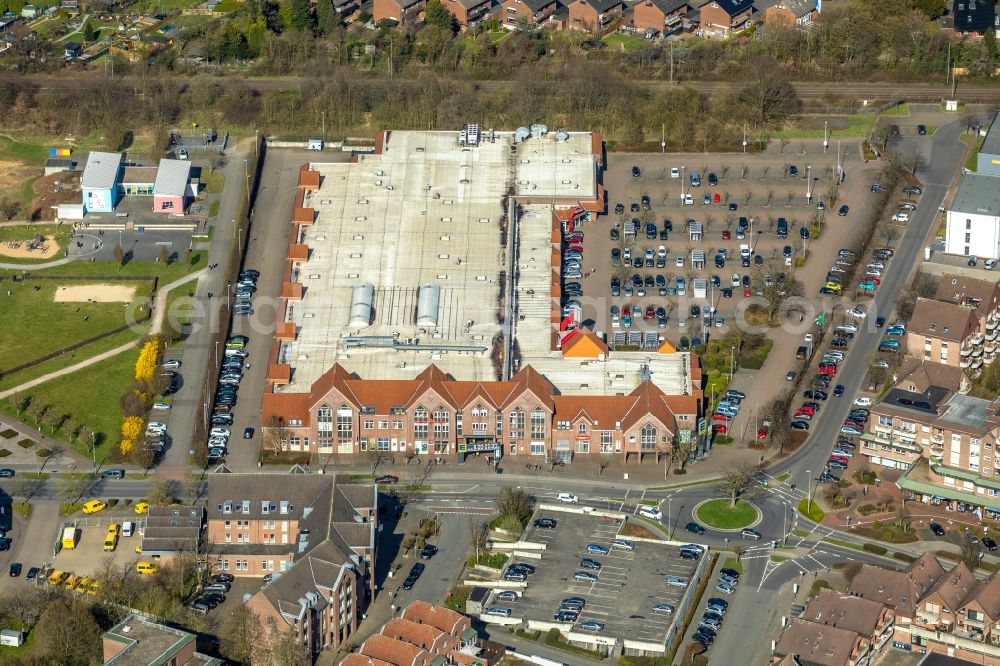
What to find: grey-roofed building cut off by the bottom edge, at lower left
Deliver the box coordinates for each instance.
[101,614,222,666]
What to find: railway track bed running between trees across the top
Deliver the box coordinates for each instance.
[0,73,1000,102]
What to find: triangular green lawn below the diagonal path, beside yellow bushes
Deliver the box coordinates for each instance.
[0,340,139,461]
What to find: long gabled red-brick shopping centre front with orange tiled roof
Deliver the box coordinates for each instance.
[263,365,700,462]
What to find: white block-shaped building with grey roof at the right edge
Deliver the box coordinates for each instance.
[944,172,1000,259]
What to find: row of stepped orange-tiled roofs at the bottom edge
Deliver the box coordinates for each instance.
[340,601,503,666]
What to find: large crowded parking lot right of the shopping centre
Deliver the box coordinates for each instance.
[564,142,870,343]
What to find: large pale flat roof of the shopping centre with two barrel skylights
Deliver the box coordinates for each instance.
[276,131,597,392]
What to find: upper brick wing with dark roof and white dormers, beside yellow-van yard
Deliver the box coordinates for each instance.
[206,474,377,580]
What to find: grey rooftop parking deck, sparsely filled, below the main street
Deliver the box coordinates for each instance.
[491,507,700,644]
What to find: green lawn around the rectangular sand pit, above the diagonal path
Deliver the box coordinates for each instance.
[0,280,149,369]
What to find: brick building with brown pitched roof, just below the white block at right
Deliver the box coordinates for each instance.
[906,298,980,372]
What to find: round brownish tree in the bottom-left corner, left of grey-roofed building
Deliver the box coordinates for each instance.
[35,597,101,664]
